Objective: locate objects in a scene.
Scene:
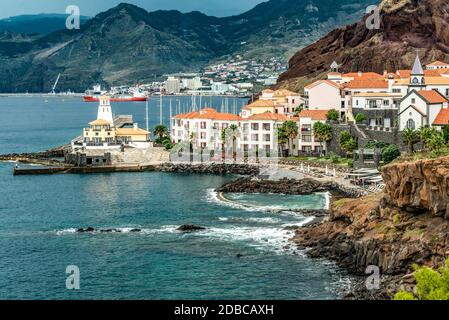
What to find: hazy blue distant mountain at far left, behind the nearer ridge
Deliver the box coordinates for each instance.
[0,14,89,34]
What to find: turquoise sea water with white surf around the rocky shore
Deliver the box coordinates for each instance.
[0,98,348,299]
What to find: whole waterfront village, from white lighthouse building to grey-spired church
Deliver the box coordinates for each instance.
[13,55,449,186]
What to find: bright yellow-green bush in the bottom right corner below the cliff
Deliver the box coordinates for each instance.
[394,259,449,300]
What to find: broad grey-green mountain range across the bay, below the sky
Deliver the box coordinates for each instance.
[0,0,376,92]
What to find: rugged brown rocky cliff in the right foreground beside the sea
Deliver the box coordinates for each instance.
[294,157,449,299]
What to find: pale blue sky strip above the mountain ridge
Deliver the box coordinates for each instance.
[0,0,266,18]
